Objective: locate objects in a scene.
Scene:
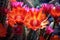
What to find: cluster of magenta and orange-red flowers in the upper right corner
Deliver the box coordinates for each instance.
[42,4,60,23]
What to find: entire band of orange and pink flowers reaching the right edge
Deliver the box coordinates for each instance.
[7,2,60,30]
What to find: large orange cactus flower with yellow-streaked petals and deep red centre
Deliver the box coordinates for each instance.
[24,9,46,31]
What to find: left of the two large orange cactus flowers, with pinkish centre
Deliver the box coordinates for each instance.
[7,7,25,26]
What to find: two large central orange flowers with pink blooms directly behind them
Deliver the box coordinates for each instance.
[7,2,46,30]
